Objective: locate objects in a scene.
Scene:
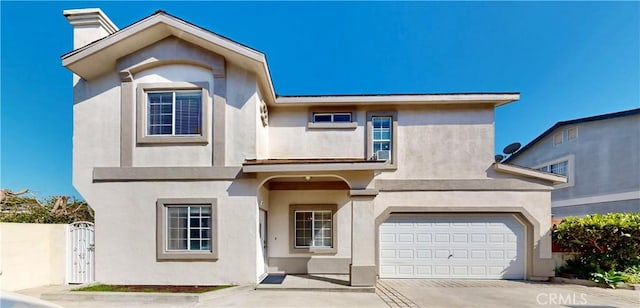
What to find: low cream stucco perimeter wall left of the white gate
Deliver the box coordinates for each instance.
[0,223,67,291]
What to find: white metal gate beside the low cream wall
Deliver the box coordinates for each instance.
[67,221,95,283]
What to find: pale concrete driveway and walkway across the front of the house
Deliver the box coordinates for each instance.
[18,276,640,308]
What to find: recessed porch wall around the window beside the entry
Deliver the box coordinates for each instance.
[267,190,351,274]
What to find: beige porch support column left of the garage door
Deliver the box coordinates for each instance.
[349,189,378,287]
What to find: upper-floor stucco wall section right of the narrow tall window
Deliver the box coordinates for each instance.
[378,107,494,179]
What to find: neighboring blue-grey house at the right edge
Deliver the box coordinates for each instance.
[506,108,640,217]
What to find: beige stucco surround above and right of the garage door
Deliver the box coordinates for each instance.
[374,191,554,278]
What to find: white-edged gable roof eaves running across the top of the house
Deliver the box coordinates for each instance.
[61,10,520,107]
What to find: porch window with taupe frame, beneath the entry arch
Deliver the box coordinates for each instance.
[289,204,338,254]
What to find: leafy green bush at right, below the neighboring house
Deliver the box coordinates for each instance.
[553,213,640,278]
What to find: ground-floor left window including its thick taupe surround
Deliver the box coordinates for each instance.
[157,198,217,260]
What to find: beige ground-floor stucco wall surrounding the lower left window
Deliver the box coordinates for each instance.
[83,180,258,285]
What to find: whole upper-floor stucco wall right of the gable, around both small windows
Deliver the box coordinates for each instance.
[269,106,494,179]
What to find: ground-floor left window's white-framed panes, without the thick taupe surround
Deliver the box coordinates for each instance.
[165,205,211,251]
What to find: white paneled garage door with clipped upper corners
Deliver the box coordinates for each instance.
[379,215,525,279]
